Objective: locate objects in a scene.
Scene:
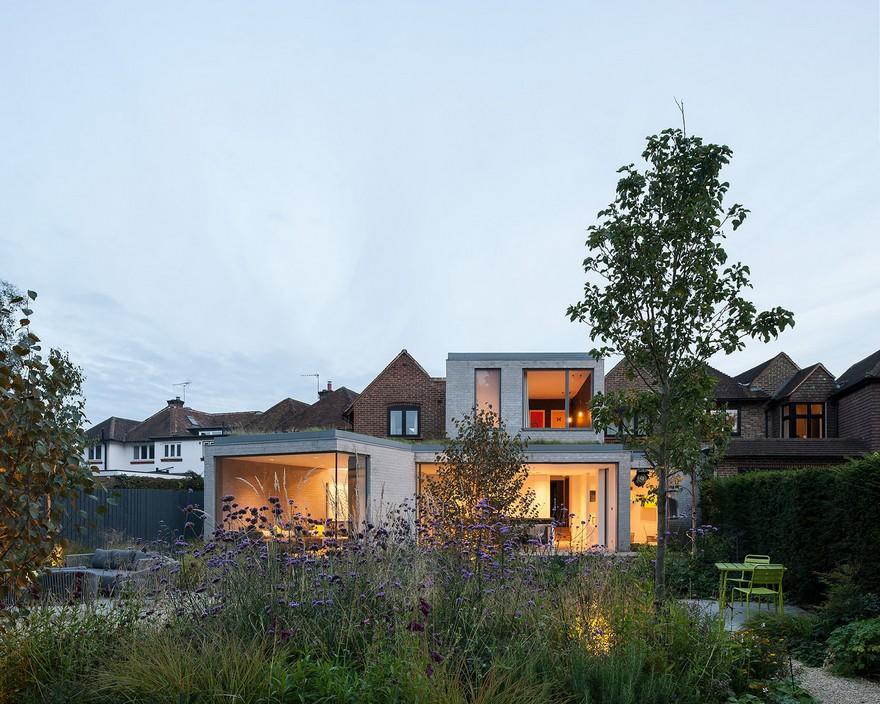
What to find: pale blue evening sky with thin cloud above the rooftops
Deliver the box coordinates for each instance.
[0,0,880,422]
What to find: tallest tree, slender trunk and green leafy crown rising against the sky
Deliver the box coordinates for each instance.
[567,129,794,603]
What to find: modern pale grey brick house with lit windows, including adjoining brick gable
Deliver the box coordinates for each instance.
[205,350,656,550]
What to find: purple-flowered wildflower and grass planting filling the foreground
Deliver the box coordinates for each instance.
[0,496,796,704]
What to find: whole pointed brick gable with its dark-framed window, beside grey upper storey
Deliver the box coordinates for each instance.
[346,350,446,440]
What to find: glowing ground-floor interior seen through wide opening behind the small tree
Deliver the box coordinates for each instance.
[419,463,607,550]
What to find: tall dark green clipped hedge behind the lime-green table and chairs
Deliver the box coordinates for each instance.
[703,453,880,603]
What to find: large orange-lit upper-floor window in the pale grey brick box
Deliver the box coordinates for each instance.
[523,369,593,430]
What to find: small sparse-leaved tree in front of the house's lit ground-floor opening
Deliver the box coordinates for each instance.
[422,409,536,530]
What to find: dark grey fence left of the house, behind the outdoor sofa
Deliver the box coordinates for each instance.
[61,487,204,547]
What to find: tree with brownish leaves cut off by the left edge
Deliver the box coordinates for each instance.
[0,291,92,584]
